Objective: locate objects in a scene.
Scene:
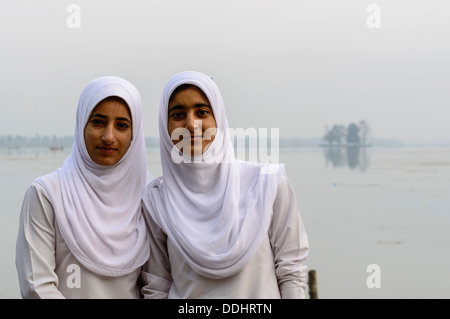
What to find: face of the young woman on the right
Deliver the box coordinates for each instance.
[167,85,217,156]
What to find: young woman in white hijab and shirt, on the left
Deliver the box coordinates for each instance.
[16,76,153,299]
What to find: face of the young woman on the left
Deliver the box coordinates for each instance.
[84,98,133,166]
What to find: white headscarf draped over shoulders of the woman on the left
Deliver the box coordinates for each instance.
[37,76,153,276]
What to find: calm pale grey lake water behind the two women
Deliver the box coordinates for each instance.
[0,147,450,299]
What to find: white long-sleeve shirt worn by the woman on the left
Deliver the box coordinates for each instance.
[16,173,141,299]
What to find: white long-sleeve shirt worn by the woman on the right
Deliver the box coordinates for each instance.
[141,178,309,299]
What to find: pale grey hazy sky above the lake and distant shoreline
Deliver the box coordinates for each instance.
[0,0,450,142]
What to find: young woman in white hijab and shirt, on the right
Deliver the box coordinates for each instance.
[142,71,309,299]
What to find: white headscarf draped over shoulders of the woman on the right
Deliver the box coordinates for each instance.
[143,71,284,278]
